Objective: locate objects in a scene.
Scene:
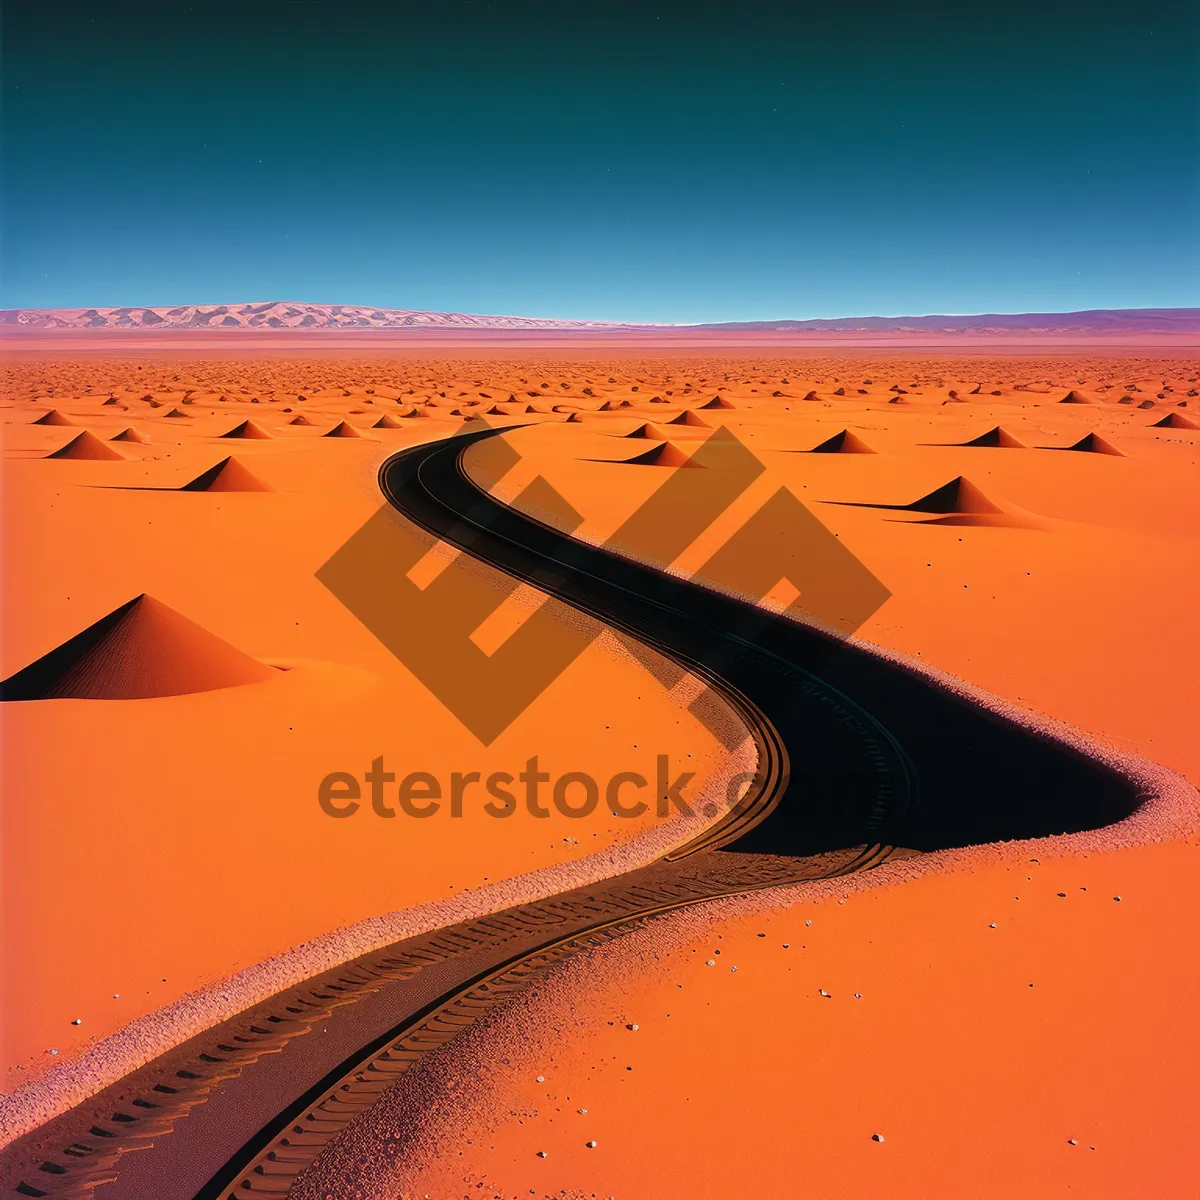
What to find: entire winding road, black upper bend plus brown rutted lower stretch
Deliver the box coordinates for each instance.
[0,430,1138,1200]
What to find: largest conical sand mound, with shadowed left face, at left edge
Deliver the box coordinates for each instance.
[0,595,275,701]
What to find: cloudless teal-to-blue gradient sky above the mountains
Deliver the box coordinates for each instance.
[0,0,1200,322]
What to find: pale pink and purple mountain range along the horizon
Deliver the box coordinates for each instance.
[0,300,1200,336]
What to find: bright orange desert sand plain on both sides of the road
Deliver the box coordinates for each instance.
[0,338,1200,1200]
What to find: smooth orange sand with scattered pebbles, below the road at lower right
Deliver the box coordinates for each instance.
[338,839,1200,1200]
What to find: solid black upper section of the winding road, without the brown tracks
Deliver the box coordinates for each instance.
[380,431,1139,856]
